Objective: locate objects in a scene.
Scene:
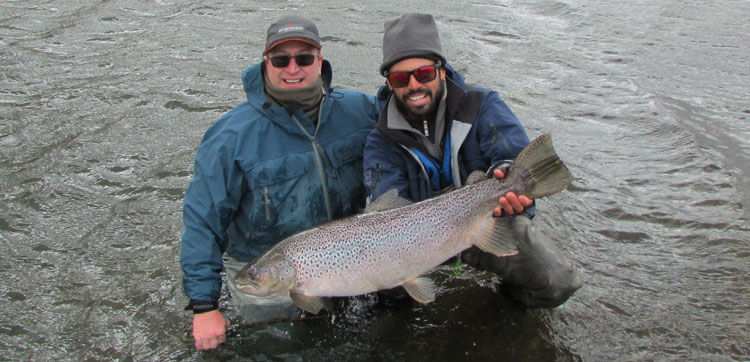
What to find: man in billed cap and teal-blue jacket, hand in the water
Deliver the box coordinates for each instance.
[180,16,378,349]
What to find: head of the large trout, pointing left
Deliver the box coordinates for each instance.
[234,254,296,297]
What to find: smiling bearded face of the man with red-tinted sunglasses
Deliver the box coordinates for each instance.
[388,58,445,119]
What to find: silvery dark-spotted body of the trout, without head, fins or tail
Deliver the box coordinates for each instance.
[248,179,501,296]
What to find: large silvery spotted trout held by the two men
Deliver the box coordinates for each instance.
[235,134,572,314]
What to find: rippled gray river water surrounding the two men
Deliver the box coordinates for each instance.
[0,0,750,361]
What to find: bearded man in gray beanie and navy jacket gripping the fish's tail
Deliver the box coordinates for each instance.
[364,14,581,308]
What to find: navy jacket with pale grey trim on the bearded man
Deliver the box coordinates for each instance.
[364,65,533,204]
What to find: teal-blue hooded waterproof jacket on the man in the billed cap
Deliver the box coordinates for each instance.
[180,60,378,304]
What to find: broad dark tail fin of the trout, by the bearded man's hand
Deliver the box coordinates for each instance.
[507,133,573,199]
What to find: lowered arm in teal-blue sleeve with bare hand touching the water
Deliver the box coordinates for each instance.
[180,123,243,349]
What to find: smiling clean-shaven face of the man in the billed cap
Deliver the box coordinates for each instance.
[263,40,323,88]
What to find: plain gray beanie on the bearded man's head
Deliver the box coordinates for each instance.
[380,14,446,75]
